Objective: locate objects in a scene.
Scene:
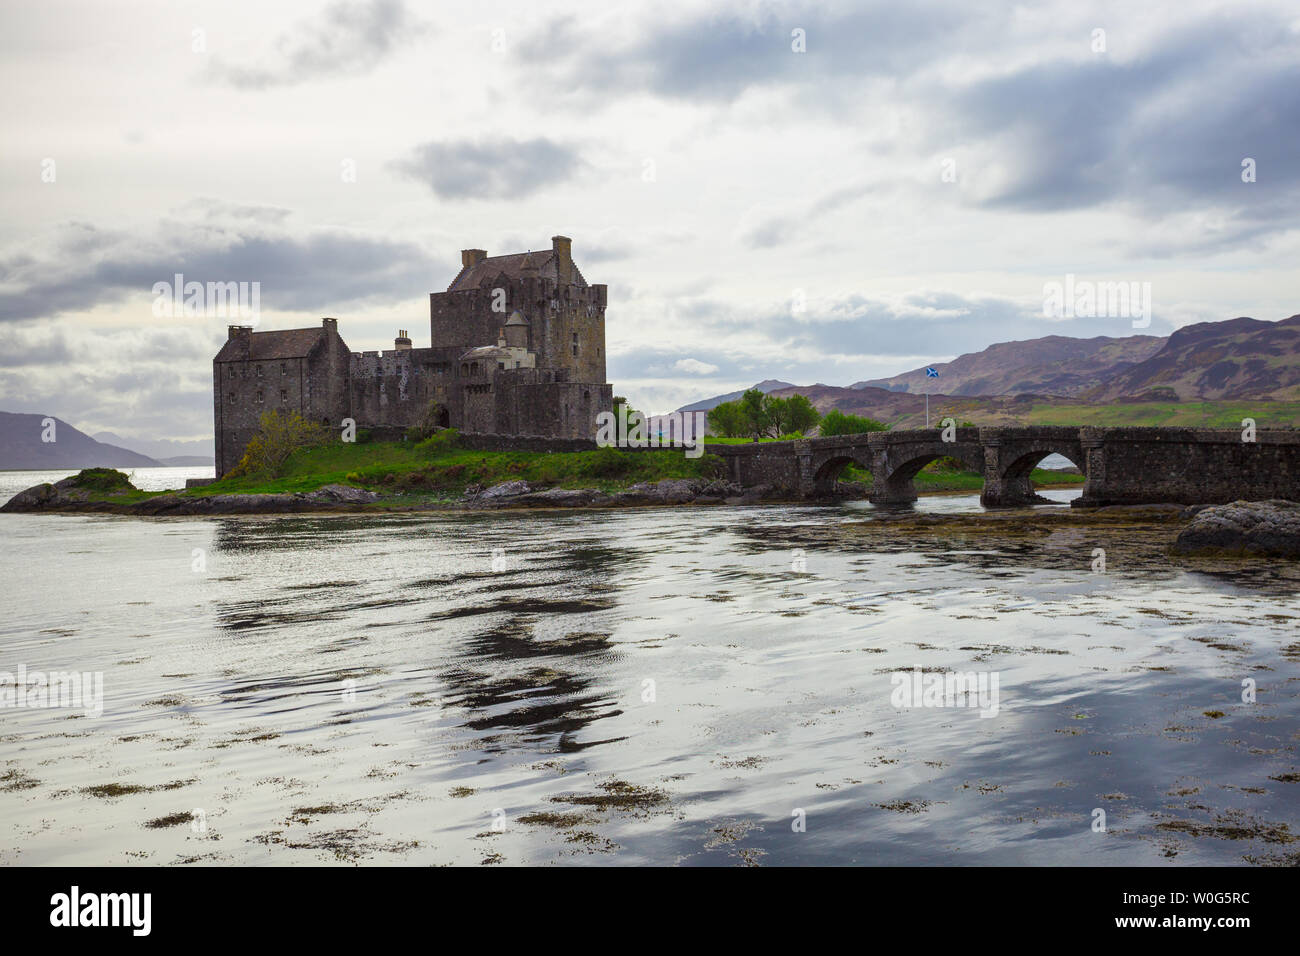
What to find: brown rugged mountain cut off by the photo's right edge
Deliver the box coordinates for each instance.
[1082,315,1300,402]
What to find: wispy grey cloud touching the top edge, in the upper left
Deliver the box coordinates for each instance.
[209,0,425,90]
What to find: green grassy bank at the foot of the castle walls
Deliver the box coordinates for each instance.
[185,442,720,498]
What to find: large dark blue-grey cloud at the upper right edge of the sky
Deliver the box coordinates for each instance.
[952,18,1300,219]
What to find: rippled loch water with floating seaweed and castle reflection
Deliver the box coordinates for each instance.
[0,475,1300,866]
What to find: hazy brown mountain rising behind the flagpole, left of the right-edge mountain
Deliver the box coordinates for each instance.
[849,335,1170,395]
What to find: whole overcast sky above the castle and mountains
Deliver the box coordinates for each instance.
[0,0,1300,440]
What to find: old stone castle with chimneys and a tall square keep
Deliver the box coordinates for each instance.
[212,235,614,477]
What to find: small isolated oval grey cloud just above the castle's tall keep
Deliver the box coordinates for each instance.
[391,137,584,199]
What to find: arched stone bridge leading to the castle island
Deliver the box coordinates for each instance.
[705,425,1300,507]
